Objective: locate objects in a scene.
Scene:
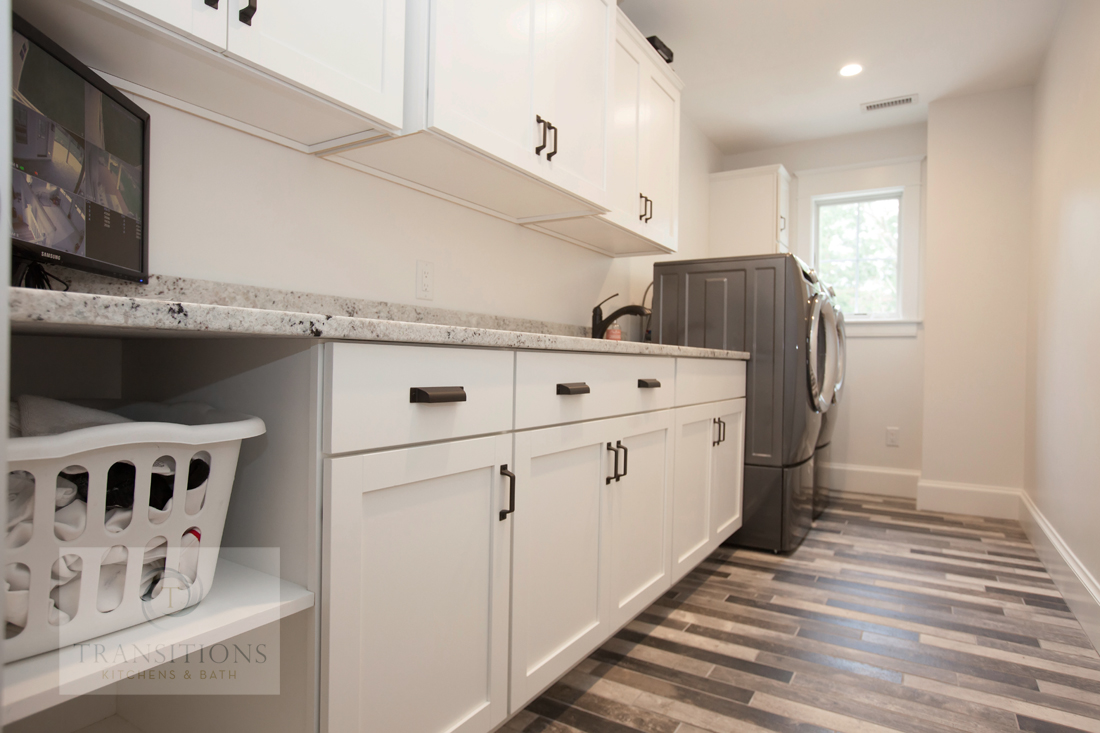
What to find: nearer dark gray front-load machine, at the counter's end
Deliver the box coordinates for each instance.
[650,254,835,551]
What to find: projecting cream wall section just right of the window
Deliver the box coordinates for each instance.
[917,87,1033,516]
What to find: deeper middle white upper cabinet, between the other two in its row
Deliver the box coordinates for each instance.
[333,0,615,223]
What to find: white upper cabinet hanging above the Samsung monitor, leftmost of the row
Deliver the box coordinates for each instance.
[21,0,406,146]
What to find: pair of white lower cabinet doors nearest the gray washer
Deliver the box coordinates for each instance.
[672,398,745,582]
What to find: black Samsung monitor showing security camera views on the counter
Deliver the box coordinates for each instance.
[11,15,149,282]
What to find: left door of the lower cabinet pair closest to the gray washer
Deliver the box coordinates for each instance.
[672,403,718,582]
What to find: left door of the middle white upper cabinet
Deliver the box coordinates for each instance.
[427,0,539,169]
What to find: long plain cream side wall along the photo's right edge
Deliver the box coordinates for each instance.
[1024,0,1100,639]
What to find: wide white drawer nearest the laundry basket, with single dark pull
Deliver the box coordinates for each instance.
[323,343,514,453]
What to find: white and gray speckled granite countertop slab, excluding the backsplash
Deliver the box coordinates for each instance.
[9,287,748,359]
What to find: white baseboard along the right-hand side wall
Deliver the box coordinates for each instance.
[1020,492,1100,649]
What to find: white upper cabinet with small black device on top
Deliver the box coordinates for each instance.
[532,12,683,256]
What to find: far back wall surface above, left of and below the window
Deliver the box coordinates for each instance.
[722,124,926,496]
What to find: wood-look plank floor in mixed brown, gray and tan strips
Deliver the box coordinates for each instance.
[503,493,1100,733]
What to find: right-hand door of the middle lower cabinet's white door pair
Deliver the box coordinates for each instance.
[603,411,673,631]
